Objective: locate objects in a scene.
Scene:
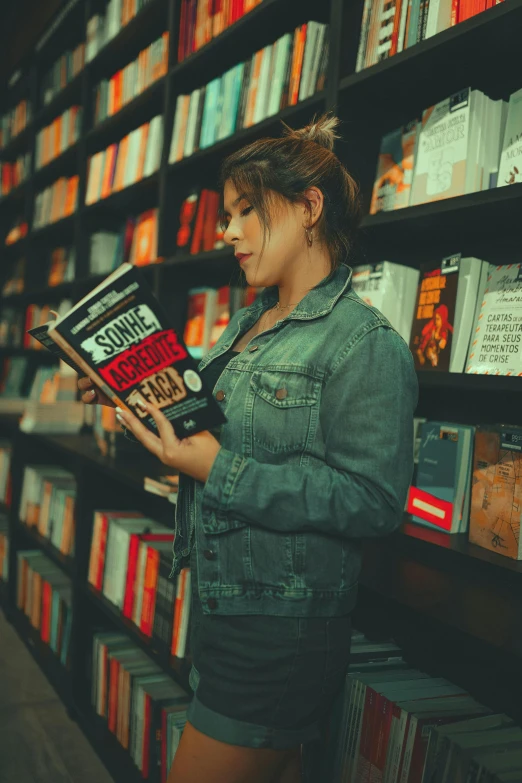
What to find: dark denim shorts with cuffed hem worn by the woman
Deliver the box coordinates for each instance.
[188,598,351,749]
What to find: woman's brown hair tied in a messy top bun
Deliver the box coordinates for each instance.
[221,114,360,272]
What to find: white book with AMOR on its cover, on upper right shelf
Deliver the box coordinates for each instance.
[410,89,483,206]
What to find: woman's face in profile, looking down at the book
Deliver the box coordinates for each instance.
[220,181,306,286]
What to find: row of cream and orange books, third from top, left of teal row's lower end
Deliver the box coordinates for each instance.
[85,115,163,204]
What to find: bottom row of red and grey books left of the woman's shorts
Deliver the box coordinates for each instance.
[91,631,190,783]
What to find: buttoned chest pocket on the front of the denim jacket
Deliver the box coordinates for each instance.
[250,371,321,454]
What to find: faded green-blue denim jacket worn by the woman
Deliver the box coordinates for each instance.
[171,265,418,616]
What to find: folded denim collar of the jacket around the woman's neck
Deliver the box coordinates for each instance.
[252,264,352,321]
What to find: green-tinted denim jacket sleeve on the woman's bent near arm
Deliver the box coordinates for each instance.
[202,324,418,538]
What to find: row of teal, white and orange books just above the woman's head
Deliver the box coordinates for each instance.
[169,22,328,163]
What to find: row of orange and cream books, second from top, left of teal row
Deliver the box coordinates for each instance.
[94,33,169,125]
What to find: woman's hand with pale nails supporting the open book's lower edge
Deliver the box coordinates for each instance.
[116,400,221,482]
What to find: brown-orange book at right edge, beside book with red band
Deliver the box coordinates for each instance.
[469,425,522,560]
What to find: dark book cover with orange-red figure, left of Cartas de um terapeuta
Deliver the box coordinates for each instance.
[410,261,452,372]
